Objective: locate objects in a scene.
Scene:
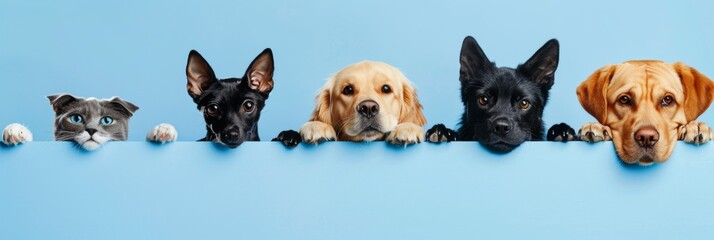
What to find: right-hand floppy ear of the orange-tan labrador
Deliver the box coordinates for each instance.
[672,62,714,121]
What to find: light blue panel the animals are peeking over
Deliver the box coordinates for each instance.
[0,142,714,240]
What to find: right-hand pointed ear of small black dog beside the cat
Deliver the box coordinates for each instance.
[241,48,275,96]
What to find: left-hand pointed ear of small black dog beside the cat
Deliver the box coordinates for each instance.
[186,50,217,102]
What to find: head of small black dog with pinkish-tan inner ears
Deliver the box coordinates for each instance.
[186,48,274,148]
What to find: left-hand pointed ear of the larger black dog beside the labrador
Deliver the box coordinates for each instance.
[459,36,495,82]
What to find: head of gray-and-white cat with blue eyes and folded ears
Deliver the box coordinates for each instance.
[47,94,139,151]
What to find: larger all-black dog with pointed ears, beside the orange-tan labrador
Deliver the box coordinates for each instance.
[426,36,572,152]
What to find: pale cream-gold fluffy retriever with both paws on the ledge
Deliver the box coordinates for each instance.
[300,61,426,145]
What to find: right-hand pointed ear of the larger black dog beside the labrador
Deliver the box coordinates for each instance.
[516,39,560,90]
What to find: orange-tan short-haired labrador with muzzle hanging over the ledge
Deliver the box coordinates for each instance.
[577,60,714,165]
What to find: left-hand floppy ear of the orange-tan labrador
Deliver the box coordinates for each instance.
[577,65,617,123]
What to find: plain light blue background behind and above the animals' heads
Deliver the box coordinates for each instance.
[0,0,714,141]
